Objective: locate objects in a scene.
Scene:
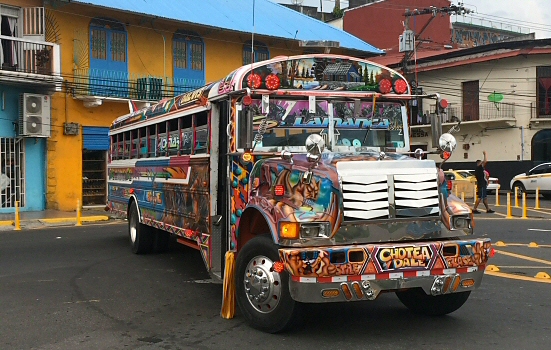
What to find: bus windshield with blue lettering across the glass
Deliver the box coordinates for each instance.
[240,100,406,151]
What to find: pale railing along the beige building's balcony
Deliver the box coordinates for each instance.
[412,103,515,125]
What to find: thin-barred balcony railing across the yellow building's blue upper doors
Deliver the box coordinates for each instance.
[73,69,205,101]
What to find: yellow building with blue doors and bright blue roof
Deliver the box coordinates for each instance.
[0,0,381,211]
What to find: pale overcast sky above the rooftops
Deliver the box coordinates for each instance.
[272,0,551,39]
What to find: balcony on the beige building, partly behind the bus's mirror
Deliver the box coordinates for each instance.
[411,103,516,129]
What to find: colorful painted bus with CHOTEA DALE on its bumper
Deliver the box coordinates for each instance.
[108,54,491,332]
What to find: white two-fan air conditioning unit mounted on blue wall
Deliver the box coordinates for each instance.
[19,94,50,137]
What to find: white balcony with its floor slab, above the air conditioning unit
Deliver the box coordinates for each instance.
[0,35,63,91]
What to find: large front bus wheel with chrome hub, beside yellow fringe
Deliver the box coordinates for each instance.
[235,235,300,333]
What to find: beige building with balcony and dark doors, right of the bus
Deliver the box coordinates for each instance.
[375,39,551,189]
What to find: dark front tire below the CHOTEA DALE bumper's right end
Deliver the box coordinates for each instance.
[396,288,471,316]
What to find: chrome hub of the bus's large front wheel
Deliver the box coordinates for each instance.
[243,256,281,313]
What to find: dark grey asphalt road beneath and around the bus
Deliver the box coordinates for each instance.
[0,214,551,350]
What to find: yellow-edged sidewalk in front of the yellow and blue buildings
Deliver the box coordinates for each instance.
[0,208,119,231]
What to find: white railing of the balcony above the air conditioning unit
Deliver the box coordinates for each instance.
[0,35,61,75]
